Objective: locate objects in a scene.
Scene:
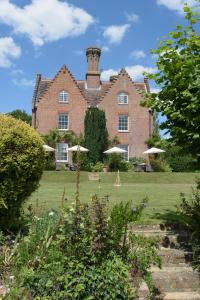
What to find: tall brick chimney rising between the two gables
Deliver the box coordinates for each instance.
[86,47,101,90]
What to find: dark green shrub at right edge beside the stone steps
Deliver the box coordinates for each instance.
[179,178,200,271]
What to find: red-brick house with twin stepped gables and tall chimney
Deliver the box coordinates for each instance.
[32,47,152,162]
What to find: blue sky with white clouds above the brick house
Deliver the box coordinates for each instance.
[0,0,198,114]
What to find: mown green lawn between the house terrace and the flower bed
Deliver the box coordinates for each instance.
[26,171,197,223]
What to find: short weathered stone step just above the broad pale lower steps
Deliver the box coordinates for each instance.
[159,247,192,266]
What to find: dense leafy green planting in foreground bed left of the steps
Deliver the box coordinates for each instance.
[6,195,158,300]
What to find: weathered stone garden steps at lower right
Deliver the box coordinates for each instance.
[134,225,200,300]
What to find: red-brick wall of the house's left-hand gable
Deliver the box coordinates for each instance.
[36,68,87,134]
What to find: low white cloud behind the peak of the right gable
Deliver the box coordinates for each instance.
[101,65,156,81]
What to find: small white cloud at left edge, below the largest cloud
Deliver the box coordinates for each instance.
[0,37,21,68]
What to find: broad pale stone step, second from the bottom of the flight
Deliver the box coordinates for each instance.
[151,266,200,292]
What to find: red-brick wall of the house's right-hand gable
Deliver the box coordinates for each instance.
[99,72,151,157]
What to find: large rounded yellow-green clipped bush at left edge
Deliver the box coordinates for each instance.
[0,115,44,228]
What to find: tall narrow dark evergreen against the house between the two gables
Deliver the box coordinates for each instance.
[84,107,108,163]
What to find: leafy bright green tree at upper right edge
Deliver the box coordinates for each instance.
[143,0,200,156]
